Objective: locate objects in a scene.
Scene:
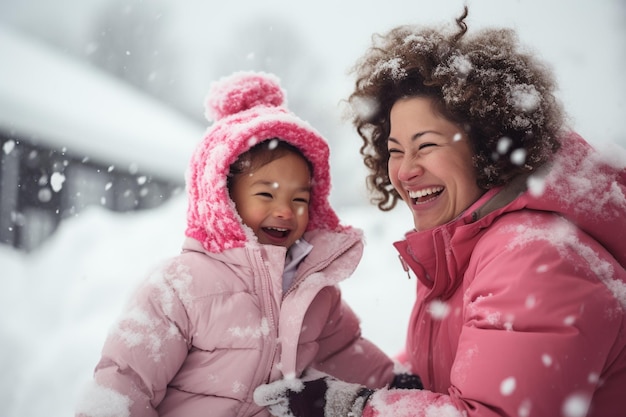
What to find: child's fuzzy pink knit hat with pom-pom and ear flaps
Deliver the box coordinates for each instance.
[185,72,344,253]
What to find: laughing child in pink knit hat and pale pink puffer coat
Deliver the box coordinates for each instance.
[77,72,394,417]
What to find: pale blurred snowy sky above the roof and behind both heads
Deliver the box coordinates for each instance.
[0,0,626,205]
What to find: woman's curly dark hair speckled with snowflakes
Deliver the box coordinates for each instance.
[348,7,564,211]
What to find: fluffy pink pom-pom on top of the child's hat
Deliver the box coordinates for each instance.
[205,71,285,121]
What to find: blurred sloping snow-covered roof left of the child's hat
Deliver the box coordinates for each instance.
[0,26,204,181]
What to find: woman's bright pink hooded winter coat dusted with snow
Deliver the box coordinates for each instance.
[363,134,626,417]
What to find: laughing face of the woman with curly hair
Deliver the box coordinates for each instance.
[388,97,484,231]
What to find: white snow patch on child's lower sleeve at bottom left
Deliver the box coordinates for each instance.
[76,381,131,417]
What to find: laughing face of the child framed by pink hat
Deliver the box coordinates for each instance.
[231,152,311,248]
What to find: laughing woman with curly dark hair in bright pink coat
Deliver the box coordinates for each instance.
[255,9,626,417]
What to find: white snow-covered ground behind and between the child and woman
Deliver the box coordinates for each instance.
[0,195,415,417]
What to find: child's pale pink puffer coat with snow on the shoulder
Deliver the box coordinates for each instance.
[79,231,393,417]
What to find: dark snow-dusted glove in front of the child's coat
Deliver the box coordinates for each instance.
[254,372,373,417]
